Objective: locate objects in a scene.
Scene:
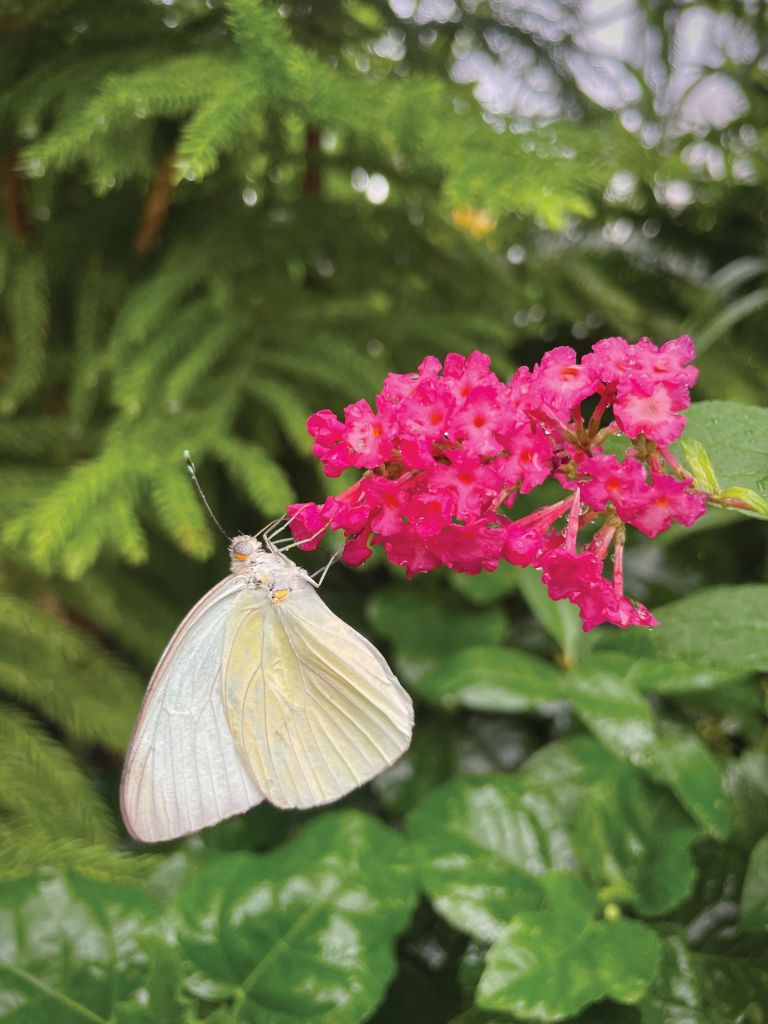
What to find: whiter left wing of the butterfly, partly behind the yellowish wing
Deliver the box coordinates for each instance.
[120,577,269,843]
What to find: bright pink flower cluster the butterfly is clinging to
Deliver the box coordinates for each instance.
[288,337,707,630]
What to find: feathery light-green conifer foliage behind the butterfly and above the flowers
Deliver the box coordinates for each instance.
[0,0,764,879]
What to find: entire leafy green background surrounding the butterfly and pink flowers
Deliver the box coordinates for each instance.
[0,0,768,1024]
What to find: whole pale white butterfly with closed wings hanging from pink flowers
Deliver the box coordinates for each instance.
[120,536,414,843]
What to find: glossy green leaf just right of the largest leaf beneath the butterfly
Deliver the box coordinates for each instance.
[407,775,573,942]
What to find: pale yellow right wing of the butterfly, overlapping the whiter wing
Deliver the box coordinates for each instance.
[224,570,414,807]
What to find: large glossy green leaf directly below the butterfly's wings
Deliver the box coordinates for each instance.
[176,811,416,1024]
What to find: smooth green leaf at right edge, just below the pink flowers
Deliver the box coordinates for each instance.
[652,584,768,672]
